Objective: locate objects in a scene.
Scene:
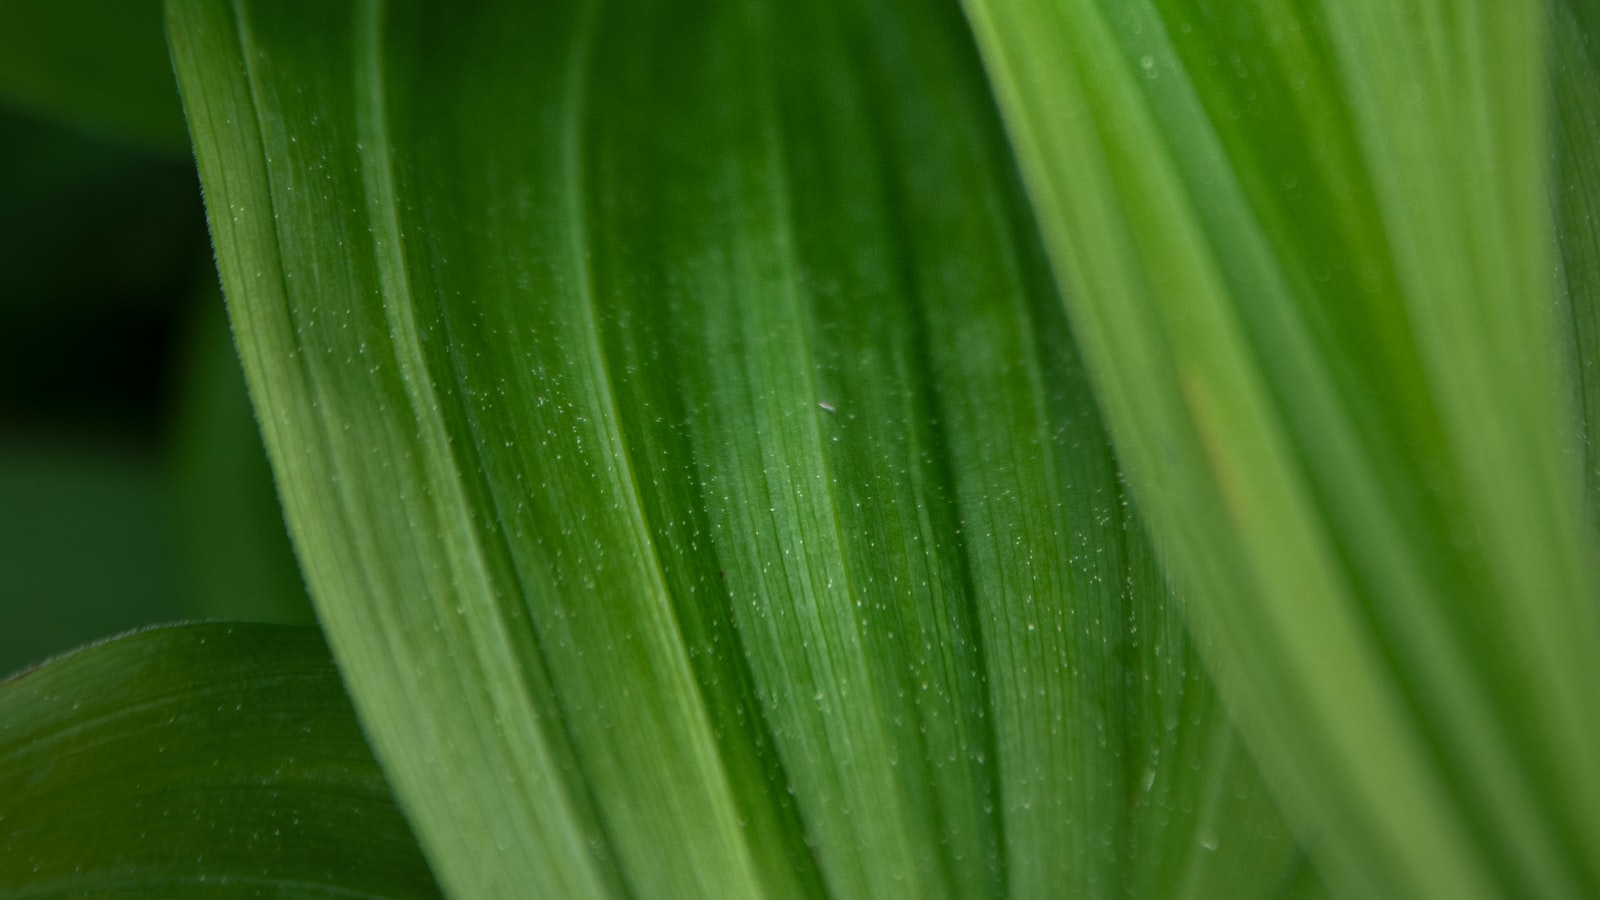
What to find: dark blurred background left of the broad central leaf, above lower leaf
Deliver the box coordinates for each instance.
[0,0,314,677]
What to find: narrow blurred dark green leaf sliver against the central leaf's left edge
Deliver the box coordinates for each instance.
[170,280,317,625]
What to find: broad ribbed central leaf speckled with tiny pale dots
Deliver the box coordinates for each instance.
[170,0,1315,898]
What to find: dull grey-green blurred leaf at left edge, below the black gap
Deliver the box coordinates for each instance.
[0,436,184,674]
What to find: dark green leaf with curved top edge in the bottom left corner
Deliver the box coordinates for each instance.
[0,625,438,898]
